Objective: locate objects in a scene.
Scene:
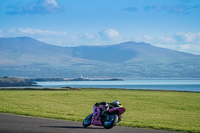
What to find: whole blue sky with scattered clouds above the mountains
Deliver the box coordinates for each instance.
[0,0,200,55]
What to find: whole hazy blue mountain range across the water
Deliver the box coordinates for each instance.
[0,37,200,78]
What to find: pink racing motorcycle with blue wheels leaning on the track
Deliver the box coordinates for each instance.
[83,103,126,129]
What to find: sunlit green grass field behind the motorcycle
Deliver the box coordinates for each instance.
[0,89,200,133]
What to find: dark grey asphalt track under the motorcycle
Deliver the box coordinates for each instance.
[0,113,182,133]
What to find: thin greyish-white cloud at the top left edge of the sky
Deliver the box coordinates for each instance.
[6,0,63,15]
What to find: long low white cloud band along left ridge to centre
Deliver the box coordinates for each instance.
[0,28,122,46]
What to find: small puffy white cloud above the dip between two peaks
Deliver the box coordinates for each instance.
[99,29,120,40]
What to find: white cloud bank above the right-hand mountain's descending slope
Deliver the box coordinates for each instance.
[132,32,200,55]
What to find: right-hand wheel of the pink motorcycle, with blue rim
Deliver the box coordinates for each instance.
[104,114,118,129]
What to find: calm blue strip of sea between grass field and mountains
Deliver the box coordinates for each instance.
[37,79,200,92]
